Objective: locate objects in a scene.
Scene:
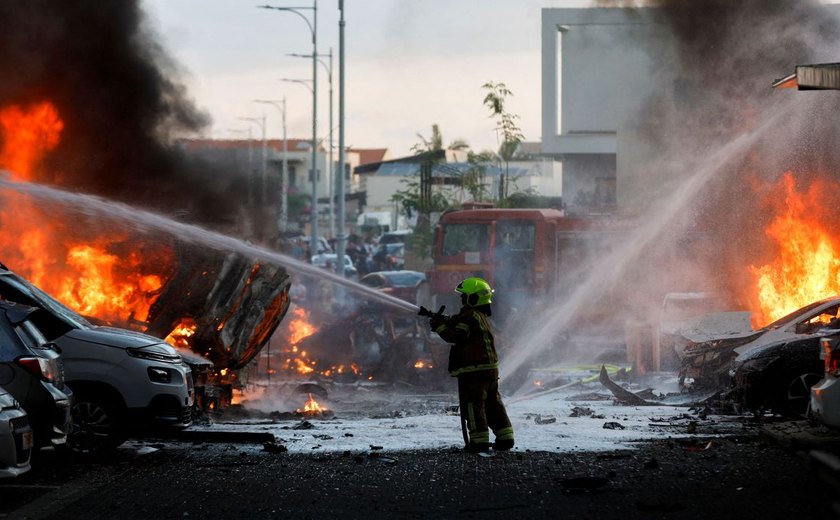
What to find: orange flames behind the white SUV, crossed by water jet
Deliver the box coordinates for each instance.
[0,101,172,324]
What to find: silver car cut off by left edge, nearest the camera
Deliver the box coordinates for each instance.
[0,387,34,478]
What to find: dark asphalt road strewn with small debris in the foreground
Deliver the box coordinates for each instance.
[0,434,840,520]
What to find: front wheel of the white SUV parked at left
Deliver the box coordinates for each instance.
[67,394,126,453]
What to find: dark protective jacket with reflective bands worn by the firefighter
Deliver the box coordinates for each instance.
[430,306,499,377]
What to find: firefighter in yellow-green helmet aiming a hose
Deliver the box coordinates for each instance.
[429,277,513,453]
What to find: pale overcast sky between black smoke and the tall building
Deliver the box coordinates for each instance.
[143,0,588,157]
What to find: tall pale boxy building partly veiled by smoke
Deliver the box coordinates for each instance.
[542,8,680,212]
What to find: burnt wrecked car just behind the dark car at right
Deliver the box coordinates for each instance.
[679,297,840,388]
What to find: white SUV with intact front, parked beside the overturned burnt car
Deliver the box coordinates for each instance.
[0,264,195,452]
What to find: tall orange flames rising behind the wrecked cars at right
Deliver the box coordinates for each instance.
[750,172,840,325]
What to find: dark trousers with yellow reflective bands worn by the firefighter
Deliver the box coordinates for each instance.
[458,370,513,445]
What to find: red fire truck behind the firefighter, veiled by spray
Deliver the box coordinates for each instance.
[428,208,626,318]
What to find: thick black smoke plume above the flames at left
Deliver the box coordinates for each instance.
[0,0,245,223]
